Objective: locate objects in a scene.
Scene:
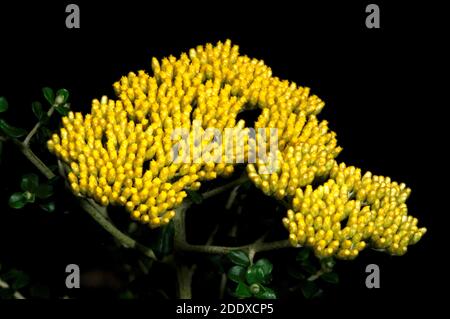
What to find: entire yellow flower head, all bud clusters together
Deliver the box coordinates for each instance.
[48,40,425,258]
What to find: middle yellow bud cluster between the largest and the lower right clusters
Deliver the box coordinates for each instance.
[247,114,341,199]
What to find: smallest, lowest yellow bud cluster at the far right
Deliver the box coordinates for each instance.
[283,163,426,259]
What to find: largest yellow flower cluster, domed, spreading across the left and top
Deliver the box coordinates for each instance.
[48,40,323,227]
